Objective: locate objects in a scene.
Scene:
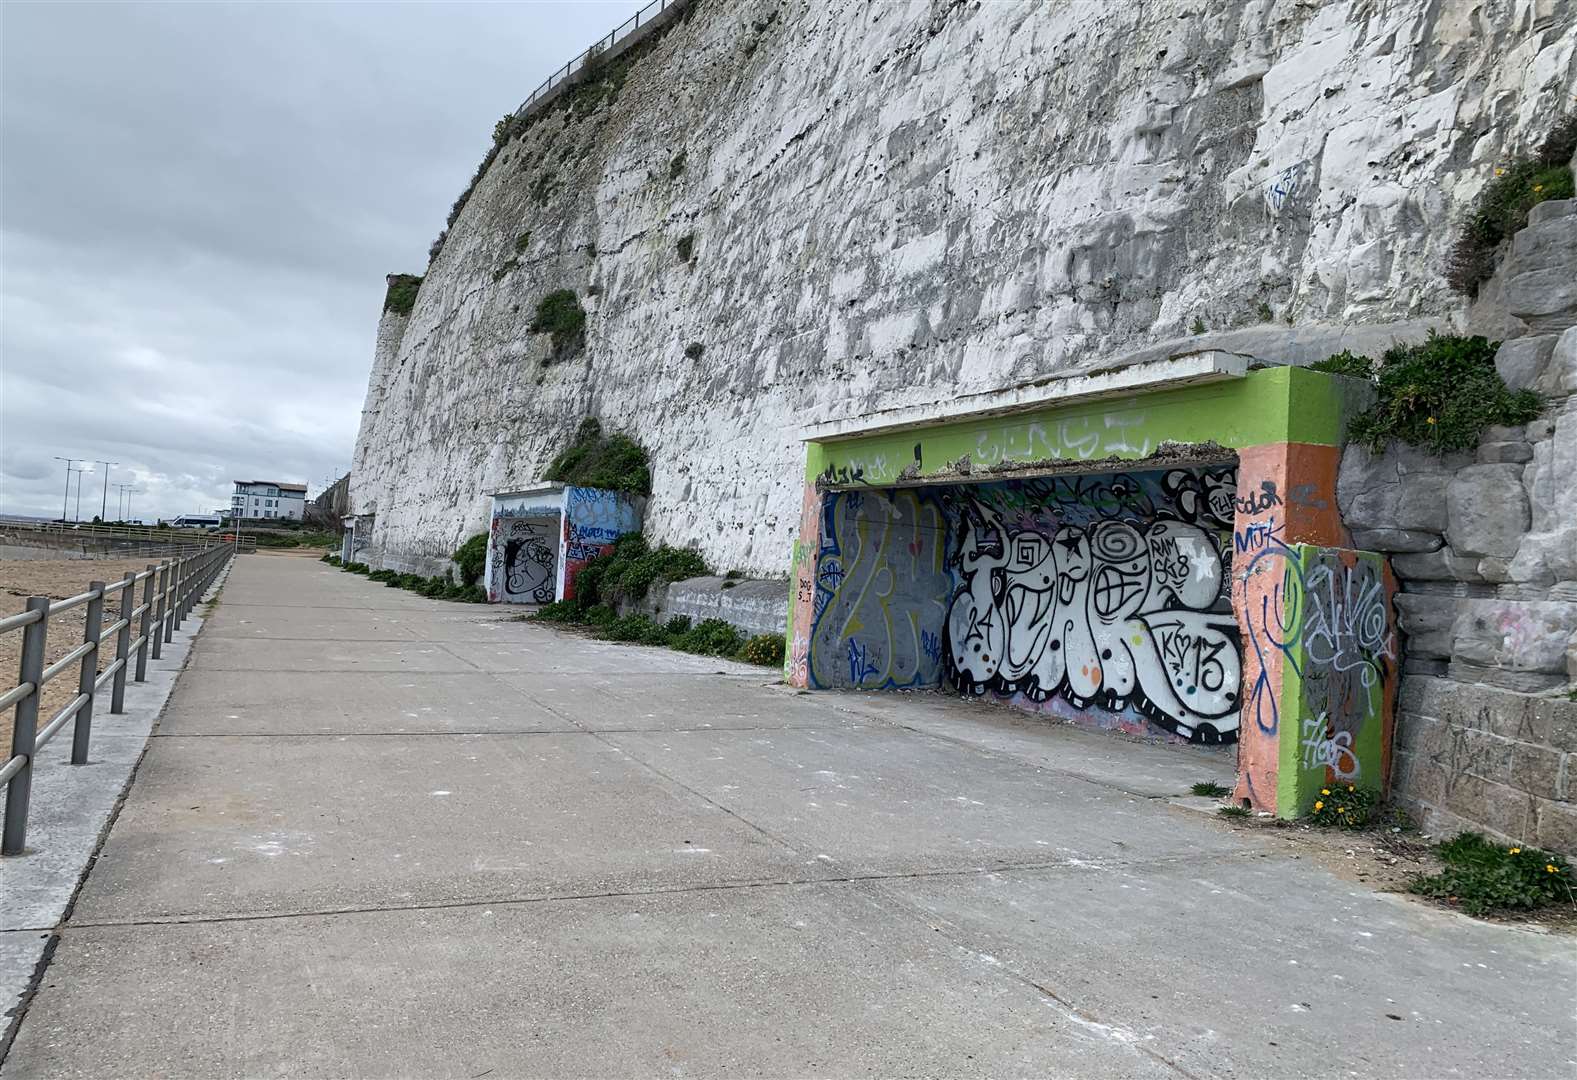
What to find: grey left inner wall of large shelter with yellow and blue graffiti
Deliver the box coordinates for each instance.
[806,489,953,689]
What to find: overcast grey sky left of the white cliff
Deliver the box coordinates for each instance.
[0,0,640,519]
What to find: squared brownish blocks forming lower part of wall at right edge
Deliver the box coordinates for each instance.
[1392,675,1577,855]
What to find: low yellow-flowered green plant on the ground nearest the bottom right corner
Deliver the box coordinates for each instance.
[1407,832,1577,914]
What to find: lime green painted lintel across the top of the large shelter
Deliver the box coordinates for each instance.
[806,367,1355,486]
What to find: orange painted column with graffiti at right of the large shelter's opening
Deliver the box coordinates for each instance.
[1232,443,1351,812]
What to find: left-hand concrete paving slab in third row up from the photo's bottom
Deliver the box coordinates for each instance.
[149,668,577,736]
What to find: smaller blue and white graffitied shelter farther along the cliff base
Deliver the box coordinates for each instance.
[483,484,647,604]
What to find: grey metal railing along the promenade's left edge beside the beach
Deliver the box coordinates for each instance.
[0,544,237,855]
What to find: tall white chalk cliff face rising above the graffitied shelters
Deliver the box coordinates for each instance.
[350,0,1577,574]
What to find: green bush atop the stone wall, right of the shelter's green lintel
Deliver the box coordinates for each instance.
[1323,333,1544,454]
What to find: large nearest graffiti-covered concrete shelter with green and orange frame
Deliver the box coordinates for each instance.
[785,352,1399,817]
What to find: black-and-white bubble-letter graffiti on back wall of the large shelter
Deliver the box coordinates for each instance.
[945,468,1241,743]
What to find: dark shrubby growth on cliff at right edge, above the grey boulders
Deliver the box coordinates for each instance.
[1446,114,1577,296]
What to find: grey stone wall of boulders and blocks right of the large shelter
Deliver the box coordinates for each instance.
[1337,193,1577,851]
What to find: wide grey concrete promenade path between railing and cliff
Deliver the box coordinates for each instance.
[0,555,1577,1080]
